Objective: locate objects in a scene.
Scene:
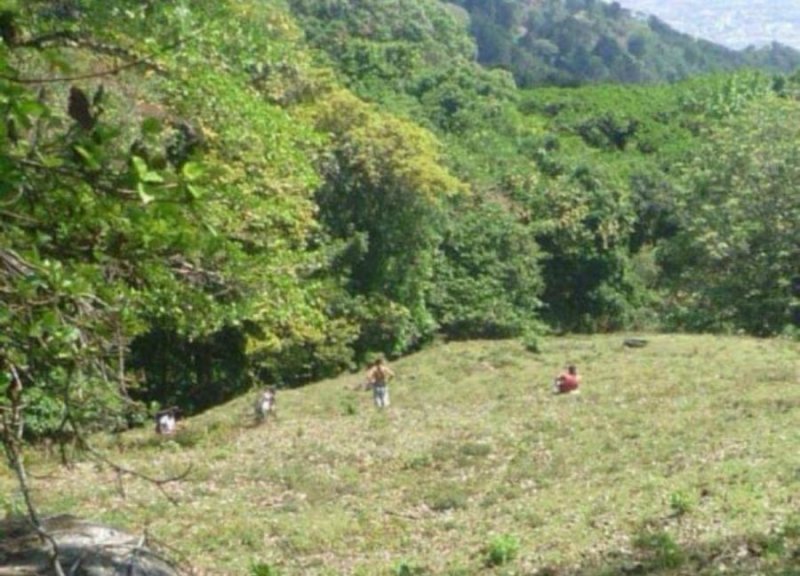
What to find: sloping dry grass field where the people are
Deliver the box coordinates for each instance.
[0,335,800,576]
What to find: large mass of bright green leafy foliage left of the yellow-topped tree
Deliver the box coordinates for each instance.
[2,3,332,428]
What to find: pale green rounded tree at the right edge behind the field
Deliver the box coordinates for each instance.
[665,96,800,335]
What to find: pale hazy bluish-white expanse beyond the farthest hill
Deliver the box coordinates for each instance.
[608,0,800,49]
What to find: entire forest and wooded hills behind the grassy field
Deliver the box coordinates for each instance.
[0,0,800,438]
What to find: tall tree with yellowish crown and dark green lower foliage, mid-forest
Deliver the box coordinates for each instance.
[316,92,463,353]
